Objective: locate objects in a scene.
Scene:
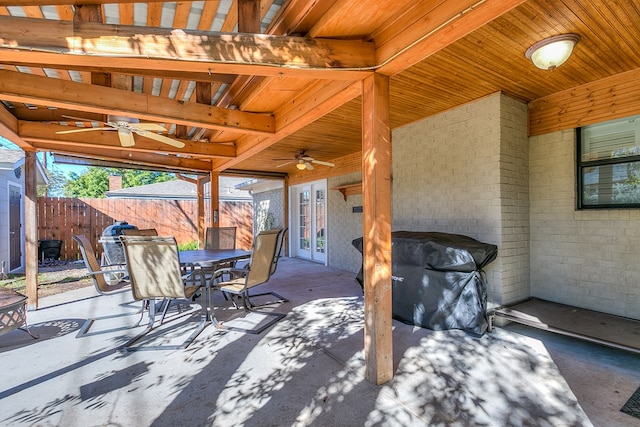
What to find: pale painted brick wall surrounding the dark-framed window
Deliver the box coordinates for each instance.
[529,130,640,319]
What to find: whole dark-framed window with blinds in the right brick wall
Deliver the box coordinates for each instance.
[576,116,640,209]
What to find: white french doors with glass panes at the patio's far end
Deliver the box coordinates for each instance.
[290,180,327,264]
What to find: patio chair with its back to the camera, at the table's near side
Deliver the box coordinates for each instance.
[120,236,208,351]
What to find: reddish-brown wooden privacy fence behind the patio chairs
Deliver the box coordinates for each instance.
[38,197,253,261]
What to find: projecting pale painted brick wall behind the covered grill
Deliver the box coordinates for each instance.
[392,94,529,304]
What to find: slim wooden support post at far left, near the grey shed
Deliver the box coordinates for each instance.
[24,151,38,310]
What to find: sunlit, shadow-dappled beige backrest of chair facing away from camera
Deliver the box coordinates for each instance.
[120,236,185,300]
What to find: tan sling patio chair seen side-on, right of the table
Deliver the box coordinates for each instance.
[209,229,288,334]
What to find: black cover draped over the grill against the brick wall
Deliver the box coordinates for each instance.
[353,231,498,335]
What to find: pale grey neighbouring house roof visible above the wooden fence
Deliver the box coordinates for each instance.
[106,177,252,201]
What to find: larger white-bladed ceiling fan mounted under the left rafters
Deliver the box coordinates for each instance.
[56,115,184,148]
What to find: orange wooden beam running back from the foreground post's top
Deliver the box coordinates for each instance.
[213,81,362,171]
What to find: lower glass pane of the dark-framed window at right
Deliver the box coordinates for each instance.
[582,162,640,206]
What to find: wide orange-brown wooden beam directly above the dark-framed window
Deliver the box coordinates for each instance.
[529,68,640,135]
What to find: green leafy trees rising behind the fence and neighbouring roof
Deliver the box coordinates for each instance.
[64,166,176,198]
